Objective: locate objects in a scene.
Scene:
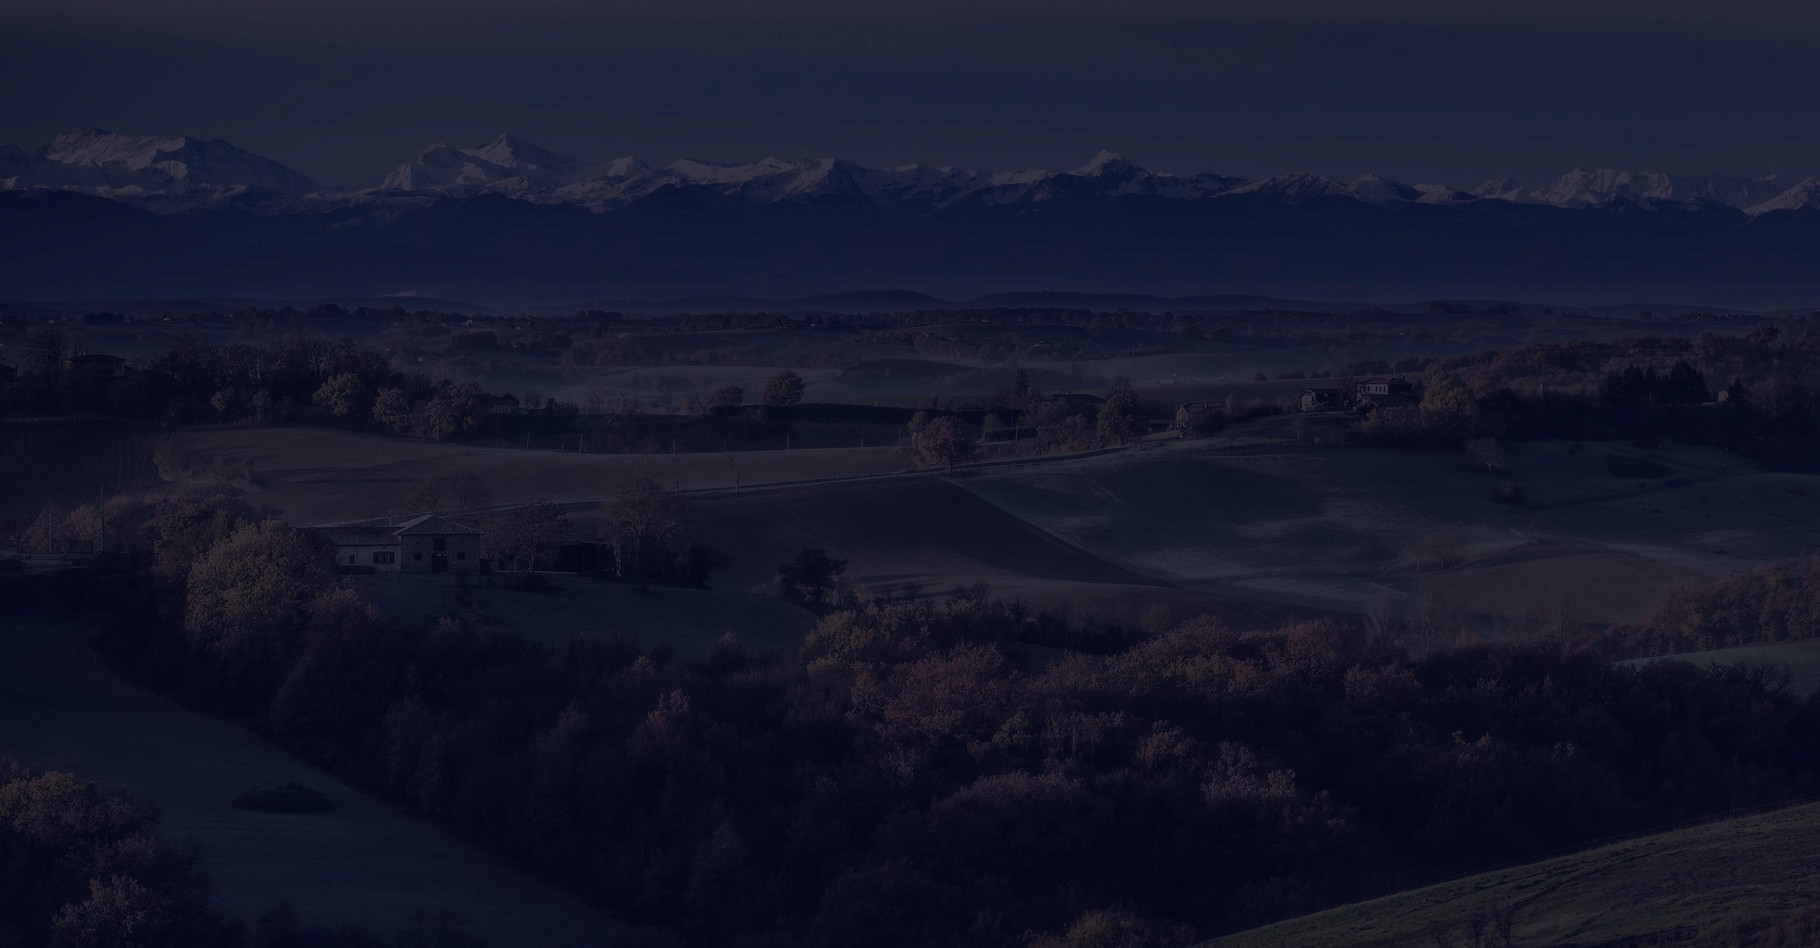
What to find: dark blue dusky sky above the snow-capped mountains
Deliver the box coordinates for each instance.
[0,0,1820,187]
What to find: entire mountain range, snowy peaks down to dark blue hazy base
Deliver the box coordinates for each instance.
[0,129,1820,298]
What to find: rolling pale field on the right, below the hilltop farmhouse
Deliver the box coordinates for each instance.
[956,435,1820,626]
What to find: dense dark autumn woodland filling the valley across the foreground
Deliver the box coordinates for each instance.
[3,504,1820,946]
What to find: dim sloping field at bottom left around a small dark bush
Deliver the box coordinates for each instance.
[0,615,664,948]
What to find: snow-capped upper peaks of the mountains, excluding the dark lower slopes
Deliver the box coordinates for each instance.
[0,129,1820,217]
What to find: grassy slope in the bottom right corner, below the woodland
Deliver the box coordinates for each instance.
[1212,804,1820,948]
